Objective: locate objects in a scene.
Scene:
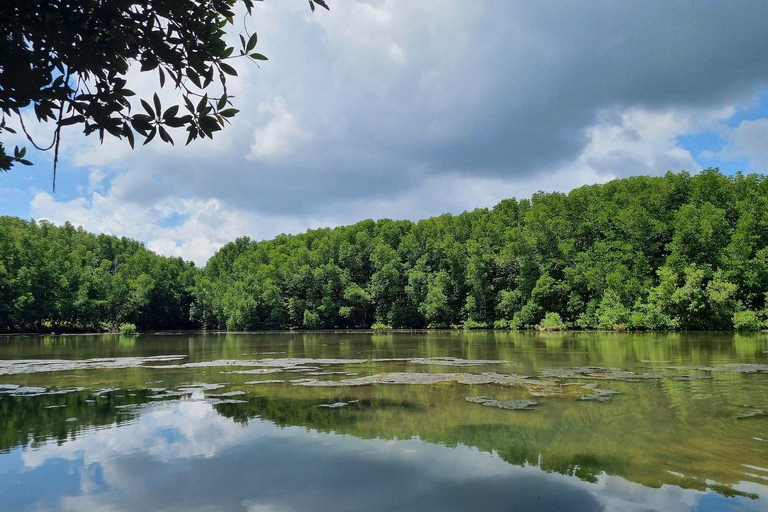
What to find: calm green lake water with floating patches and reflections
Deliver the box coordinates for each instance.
[0,332,768,512]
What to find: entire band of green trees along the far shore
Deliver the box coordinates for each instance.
[0,169,768,330]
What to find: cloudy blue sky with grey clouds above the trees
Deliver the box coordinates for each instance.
[0,0,768,265]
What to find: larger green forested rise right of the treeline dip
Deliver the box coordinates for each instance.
[194,169,768,330]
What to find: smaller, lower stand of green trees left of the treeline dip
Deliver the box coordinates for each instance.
[0,217,199,331]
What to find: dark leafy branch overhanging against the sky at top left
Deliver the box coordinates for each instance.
[0,0,328,185]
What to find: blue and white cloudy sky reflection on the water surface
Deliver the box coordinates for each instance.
[0,400,766,511]
